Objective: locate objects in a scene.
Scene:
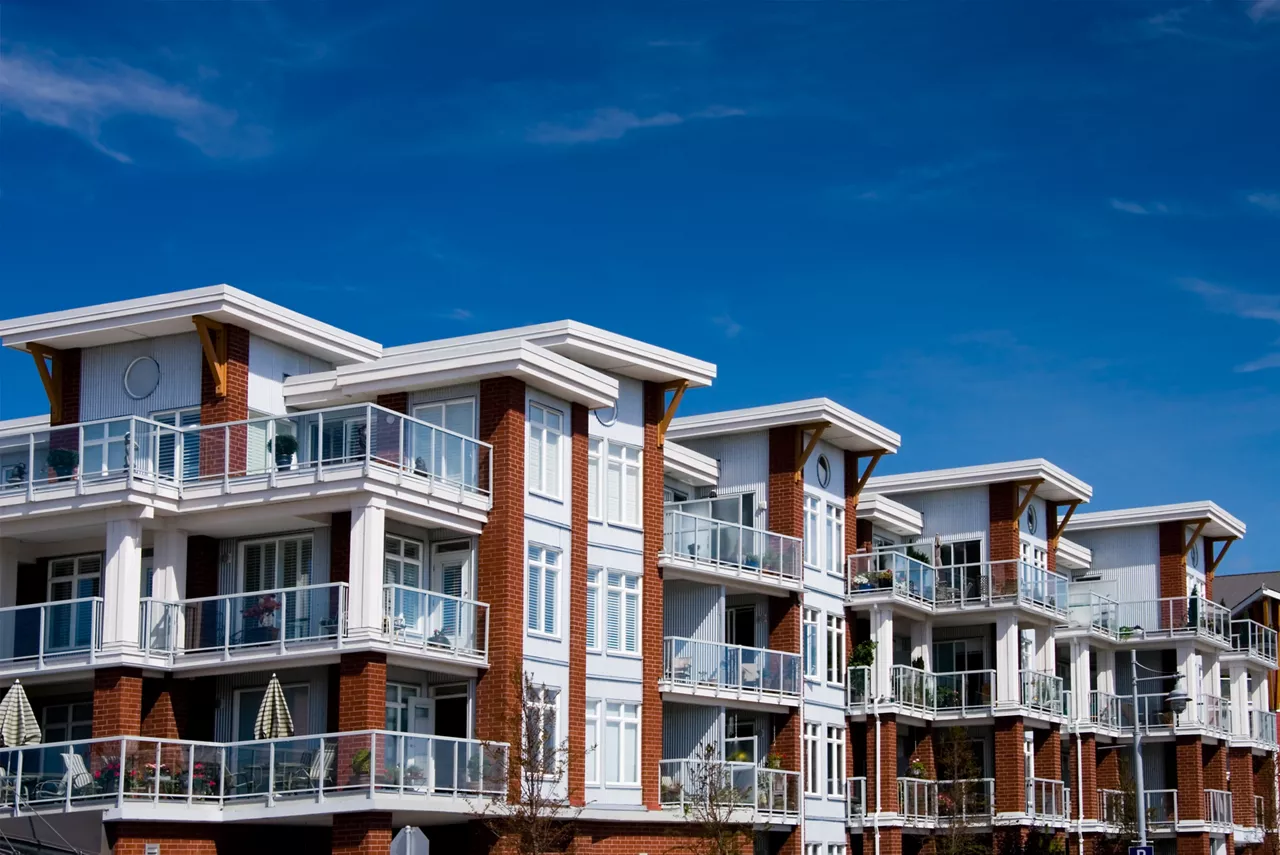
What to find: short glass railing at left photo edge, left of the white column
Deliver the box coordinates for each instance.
[0,596,102,671]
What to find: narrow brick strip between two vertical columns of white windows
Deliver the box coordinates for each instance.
[568,403,588,805]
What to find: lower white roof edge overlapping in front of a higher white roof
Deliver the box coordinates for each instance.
[284,340,618,410]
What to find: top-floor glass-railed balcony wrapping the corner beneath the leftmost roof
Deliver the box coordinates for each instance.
[0,404,493,512]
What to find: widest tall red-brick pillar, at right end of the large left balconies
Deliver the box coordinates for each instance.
[476,378,524,794]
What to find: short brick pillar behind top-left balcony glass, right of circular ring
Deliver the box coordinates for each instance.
[200,324,248,477]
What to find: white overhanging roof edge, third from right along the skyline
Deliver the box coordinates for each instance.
[667,398,902,454]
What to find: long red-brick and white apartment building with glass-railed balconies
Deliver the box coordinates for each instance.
[0,285,1276,855]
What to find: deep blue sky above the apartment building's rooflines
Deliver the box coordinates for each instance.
[0,0,1280,571]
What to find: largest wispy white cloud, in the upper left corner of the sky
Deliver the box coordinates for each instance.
[0,49,270,163]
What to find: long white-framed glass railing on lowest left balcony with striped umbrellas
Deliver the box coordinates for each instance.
[0,730,508,814]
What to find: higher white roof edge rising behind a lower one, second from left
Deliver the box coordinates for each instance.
[384,320,716,387]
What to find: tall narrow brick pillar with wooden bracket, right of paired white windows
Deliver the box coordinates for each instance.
[640,381,667,810]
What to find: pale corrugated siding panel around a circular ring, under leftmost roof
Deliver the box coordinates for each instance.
[81,330,202,421]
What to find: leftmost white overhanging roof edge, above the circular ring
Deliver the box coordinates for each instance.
[0,285,383,365]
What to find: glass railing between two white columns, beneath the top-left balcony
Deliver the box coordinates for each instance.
[138,582,348,660]
